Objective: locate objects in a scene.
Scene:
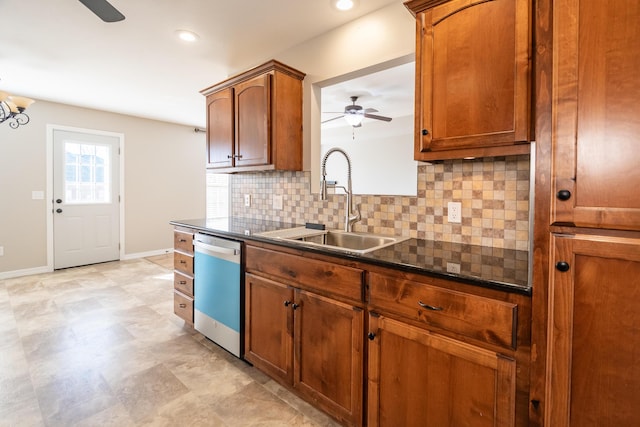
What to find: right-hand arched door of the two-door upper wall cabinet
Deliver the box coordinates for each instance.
[235,74,271,166]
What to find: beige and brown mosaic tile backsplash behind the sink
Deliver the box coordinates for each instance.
[230,155,530,250]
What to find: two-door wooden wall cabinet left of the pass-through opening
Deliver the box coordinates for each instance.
[201,61,305,172]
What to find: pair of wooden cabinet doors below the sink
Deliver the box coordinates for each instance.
[245,273,364,425]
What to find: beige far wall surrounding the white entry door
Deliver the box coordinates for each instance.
[0,100,205,278]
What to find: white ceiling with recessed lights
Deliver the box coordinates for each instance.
[0,0,400,127]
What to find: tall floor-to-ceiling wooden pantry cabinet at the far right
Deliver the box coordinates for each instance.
[530,0,640,427]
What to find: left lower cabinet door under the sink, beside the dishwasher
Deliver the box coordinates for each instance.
[244,274,293,384]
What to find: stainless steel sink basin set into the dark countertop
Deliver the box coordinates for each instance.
[258,227,408,254]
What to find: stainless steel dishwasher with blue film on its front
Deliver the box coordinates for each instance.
[193,233,242,357]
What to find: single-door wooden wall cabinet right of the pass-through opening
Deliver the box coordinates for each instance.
[405,0,531,161]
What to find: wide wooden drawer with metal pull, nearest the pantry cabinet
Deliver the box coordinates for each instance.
[369,273,518,349]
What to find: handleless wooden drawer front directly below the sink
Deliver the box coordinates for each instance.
[246,246,364,301]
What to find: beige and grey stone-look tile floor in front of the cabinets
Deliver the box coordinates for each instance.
[0,255,338,427]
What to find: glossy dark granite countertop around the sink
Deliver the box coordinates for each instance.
[170,218,531,295]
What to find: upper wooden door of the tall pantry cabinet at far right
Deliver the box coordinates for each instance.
[552,0,640,230]
